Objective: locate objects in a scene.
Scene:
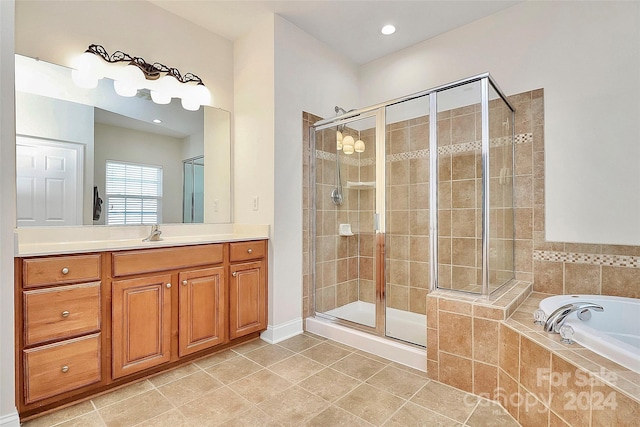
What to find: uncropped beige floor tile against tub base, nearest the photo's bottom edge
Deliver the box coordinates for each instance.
[411,381,478,422]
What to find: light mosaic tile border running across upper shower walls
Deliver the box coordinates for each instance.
[316,133,533,166]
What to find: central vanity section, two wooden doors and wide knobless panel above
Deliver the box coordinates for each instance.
[112,244,227,379]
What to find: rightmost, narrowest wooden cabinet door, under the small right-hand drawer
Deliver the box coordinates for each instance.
[229,261,267,339]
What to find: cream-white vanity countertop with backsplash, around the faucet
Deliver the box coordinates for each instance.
[14,224,269,257]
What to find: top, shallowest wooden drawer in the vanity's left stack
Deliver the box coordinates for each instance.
[22,254,100,288]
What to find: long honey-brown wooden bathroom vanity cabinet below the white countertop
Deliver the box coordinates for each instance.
[15,232,267,419]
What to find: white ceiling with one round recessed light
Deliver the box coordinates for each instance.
[149,0,523,64]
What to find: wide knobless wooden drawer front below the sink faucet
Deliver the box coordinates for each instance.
[112,244,224,277]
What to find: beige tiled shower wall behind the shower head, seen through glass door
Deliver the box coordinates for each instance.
[304,123,375,312]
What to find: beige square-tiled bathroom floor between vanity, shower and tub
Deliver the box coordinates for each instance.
[23,333,519,427]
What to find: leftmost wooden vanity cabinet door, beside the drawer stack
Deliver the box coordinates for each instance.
[112,274,171,378]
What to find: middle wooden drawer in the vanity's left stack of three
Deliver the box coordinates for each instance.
[24,282,100,345]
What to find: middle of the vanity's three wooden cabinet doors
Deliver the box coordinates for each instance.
[178,267,227,357]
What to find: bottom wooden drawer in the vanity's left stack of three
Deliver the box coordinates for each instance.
[24,334,101,403]
